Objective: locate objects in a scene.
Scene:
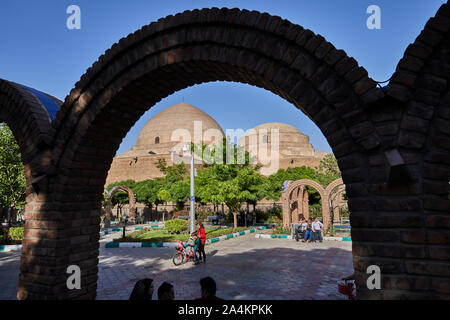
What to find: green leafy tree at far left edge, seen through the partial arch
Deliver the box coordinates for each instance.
[0,123,26,209]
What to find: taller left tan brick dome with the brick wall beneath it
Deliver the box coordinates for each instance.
[106,103,225,185]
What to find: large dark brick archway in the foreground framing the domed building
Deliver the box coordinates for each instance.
[0,4,450,299]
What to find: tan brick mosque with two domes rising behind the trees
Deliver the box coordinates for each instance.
[106,103,327,186]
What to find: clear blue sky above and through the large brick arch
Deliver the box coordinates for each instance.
[0,0,445,154]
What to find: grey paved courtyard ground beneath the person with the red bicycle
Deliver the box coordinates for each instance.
[0,234,353,300]
